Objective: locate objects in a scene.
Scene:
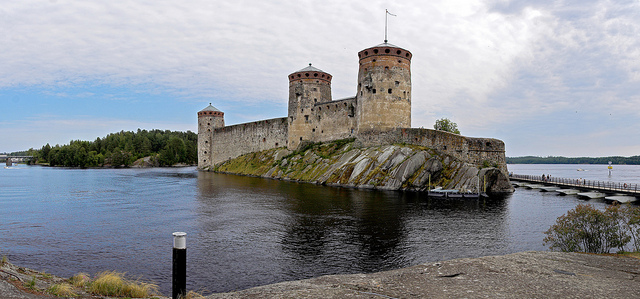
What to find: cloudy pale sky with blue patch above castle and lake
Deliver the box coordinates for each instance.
[0,0,640,157]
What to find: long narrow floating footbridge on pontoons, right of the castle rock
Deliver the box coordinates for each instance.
[509,174,640,197]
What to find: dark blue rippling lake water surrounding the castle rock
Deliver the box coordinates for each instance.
[0,165,640,295]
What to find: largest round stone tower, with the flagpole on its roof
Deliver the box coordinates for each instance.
[356,41,412,131]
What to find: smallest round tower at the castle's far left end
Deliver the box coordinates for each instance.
[198,103,224,169]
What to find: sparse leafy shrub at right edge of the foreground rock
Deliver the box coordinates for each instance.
[544,204,631,253]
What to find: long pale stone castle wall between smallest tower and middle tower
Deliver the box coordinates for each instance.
[208,117,289,168]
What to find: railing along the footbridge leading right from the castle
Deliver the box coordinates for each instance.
[509,174,640,195]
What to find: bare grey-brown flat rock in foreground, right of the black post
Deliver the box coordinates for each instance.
[207,252,640,299]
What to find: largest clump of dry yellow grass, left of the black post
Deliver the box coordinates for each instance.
[89,271,158,298]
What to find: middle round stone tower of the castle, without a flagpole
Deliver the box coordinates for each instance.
[287,63,331,149]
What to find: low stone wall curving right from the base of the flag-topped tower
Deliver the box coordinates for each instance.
[357,128,507,173]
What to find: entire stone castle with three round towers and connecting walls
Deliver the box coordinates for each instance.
[198,41,506,172]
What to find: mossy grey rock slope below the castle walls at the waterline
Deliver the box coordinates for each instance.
[214,140,513,193]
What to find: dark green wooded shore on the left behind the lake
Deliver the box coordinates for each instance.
[26,129,198,168]
